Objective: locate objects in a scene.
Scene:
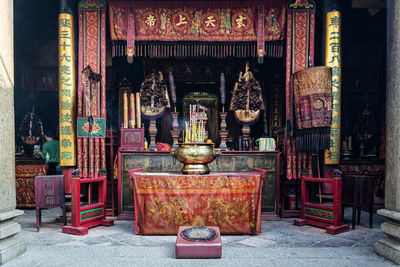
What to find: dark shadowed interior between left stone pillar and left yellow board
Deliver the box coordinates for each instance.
[14,0,78,142]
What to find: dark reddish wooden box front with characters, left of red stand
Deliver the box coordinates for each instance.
[35,175,65,208]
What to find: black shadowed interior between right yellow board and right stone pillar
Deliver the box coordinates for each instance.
[342,8,386,156]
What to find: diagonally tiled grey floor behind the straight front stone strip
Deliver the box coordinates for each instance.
[16,208,385,248]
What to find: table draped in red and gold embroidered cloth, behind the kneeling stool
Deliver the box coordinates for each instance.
[129,169,266,235]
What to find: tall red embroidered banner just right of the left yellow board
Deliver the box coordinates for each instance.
[77,0,106,177]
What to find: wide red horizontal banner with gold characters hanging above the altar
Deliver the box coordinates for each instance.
[109,2,286,42]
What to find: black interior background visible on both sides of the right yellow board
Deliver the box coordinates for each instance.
[315,0,386,157]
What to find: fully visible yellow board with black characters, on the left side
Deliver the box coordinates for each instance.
[58,13,76,166]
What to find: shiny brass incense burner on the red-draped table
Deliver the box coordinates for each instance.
[170,143,221,174]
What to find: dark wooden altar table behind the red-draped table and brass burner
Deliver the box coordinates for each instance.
[118,149,280,220]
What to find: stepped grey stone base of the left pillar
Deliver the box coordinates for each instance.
[0,210,26,265]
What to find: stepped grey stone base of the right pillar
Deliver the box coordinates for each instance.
[375,209,400,264]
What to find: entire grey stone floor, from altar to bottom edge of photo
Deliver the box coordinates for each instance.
[4,209,394,267]
